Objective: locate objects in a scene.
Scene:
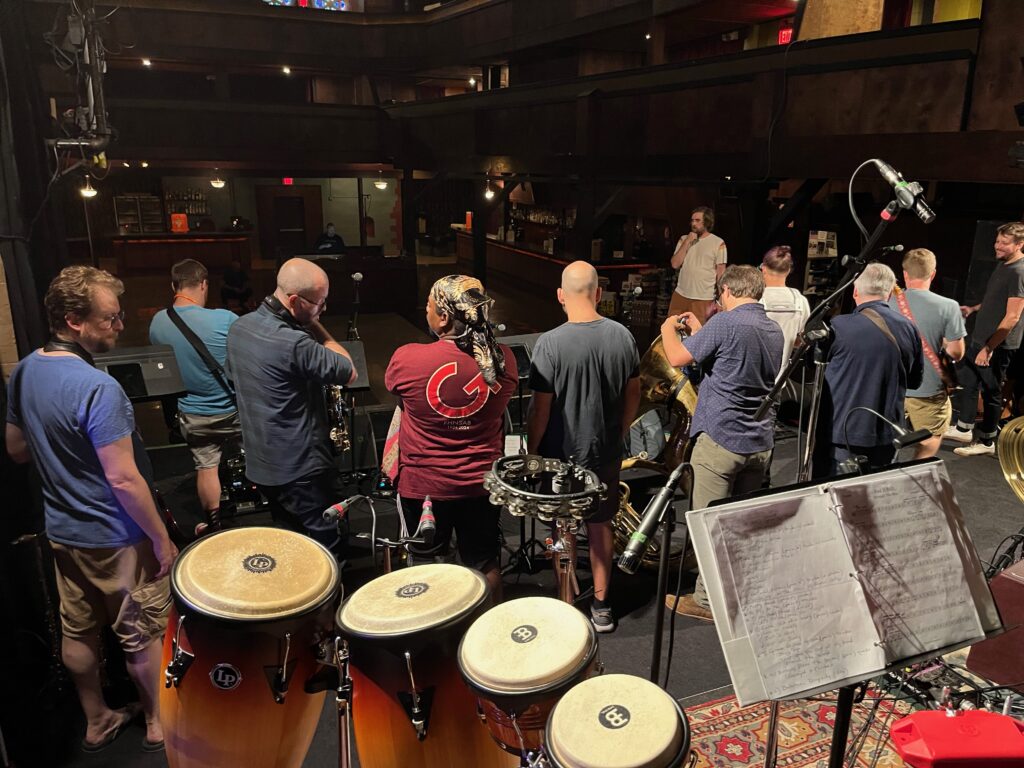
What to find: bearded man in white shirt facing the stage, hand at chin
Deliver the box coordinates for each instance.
[669,207,728,323]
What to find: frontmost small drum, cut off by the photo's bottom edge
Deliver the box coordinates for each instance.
[544,675,690,768]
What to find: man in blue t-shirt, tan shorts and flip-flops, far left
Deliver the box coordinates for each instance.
[6,266,177,752]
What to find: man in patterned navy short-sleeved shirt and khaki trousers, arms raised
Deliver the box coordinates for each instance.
[662,265,785,621]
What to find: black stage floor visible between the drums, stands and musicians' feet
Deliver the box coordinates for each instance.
[48,439,1024,768]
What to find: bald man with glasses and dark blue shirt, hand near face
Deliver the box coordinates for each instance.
[227,259,355,560]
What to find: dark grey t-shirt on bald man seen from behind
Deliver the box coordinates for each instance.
[529,317,640,470]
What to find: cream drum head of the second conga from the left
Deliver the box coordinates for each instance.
[337,563,489,639]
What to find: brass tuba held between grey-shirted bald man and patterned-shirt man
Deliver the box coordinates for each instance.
[612,329,697,568]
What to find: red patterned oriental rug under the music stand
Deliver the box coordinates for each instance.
[686,691,911,768]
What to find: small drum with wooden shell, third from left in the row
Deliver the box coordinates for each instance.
[459,597,598,756]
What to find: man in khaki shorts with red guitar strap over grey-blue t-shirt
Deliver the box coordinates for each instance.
[889,248,967,459]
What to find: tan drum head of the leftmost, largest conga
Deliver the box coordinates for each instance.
[171,527,339,622]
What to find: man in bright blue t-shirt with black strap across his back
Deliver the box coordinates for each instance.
[150,259,242,534]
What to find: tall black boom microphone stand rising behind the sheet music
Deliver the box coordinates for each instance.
[754,200,900,482]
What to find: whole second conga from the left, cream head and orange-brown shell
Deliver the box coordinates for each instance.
[337,564,517,768]
